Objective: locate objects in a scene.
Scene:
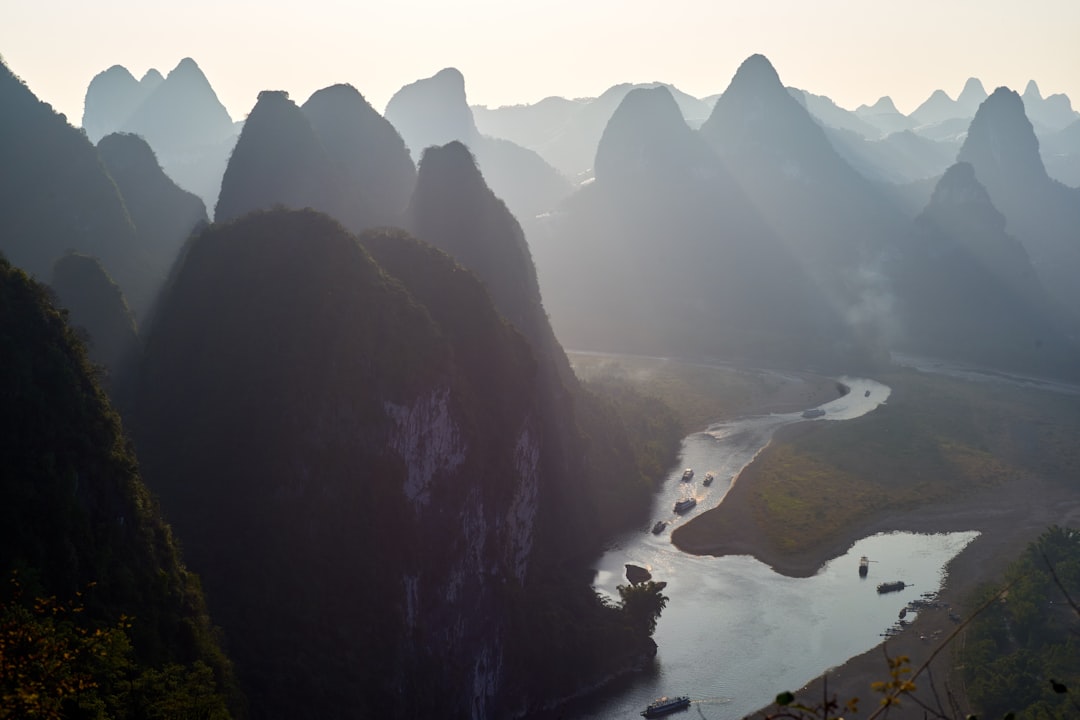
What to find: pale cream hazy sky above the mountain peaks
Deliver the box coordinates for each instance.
[0,0,1080,124]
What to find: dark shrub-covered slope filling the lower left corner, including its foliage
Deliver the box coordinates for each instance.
[0,253,240,717]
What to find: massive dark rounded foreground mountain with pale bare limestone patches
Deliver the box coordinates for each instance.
[138,210,544,718]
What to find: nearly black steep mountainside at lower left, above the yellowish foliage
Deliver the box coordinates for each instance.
[0,257,242,717]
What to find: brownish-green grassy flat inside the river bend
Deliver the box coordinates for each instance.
[684,372,1080,552]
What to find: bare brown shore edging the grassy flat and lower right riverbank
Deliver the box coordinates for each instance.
[672,444,1080,718]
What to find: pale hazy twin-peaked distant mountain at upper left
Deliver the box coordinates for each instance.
[83,57,238,208]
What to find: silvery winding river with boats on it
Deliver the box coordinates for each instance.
[565,378,976,720]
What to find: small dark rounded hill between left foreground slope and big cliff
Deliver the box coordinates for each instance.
[50,253,138,376]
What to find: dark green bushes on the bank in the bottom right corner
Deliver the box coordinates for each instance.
[958,526,1080,720]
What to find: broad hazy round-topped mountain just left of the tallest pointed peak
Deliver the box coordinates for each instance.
[534,87,842,363]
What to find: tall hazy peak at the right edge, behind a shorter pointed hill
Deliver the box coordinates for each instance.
[957,87,1080,316]
